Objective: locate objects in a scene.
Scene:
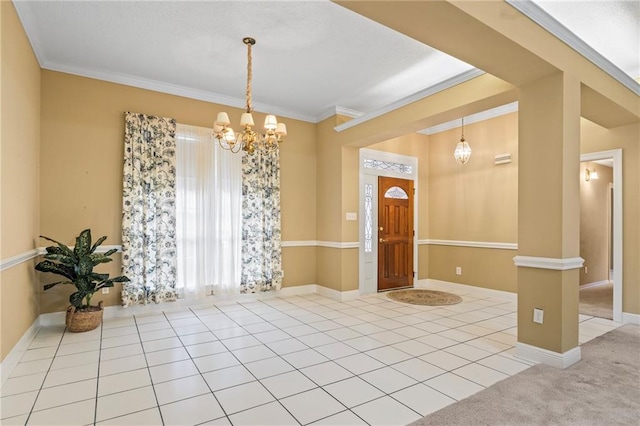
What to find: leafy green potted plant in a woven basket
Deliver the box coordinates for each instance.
[36,229,129,332]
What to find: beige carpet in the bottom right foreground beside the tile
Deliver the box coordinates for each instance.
[411,324,640,426]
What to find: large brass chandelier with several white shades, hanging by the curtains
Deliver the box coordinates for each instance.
[213,37,287,154]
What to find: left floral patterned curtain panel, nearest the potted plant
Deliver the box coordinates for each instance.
[122,112,176,306]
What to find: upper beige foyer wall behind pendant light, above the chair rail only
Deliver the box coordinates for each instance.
[429,113,518,243]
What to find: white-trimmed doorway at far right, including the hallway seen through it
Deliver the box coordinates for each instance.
[579,150,622,322]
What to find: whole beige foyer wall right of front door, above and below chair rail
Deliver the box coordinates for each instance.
[428,113,518,292]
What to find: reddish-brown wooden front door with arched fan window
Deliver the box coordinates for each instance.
[378,176,414,291]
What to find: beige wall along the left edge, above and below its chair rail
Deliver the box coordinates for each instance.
[0,1,40,360]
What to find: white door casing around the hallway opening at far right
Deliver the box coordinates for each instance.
[580,149,624,323]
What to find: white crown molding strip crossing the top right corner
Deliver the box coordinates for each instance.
[505,0,640,95]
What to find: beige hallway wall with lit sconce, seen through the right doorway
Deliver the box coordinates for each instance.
[580,162,613,285]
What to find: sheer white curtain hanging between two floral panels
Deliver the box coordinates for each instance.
[176,124,242,298]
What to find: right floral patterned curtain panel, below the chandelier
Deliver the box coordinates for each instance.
[240,143,282,293]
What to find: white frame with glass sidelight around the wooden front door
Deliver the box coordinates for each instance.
[358,148,419,294]
